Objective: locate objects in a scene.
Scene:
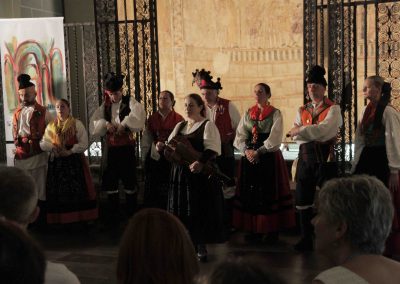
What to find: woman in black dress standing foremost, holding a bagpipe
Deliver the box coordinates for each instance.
[161,94,225,261]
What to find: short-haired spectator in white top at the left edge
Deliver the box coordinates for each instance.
[0,166,80,284]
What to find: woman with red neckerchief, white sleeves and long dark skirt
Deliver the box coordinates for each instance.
[233,83,295,242]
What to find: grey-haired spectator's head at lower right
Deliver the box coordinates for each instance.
[313,175,393,254]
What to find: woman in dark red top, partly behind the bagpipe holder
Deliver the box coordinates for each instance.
[141,90,183,209]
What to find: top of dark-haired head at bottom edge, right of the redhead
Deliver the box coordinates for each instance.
[202,258,284,284]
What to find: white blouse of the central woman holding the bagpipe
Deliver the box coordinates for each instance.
[168,119,221,156]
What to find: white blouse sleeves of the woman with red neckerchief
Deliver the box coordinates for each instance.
[233,109,283,155]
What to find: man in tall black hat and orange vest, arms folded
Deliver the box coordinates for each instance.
[288,65,343,252]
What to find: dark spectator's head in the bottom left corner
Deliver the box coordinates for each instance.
[0,220,46,284]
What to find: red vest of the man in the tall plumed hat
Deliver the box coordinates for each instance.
[215,98,235,144]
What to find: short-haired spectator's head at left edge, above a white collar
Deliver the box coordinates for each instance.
[0,166,39,226]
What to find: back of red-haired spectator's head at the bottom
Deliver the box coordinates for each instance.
[117,208,199,284]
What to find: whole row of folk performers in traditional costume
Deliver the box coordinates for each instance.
[13,65,400,261]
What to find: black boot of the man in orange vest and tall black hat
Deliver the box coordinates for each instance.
[294,208,314,252]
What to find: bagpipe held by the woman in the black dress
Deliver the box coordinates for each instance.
[164,136,231,183]
